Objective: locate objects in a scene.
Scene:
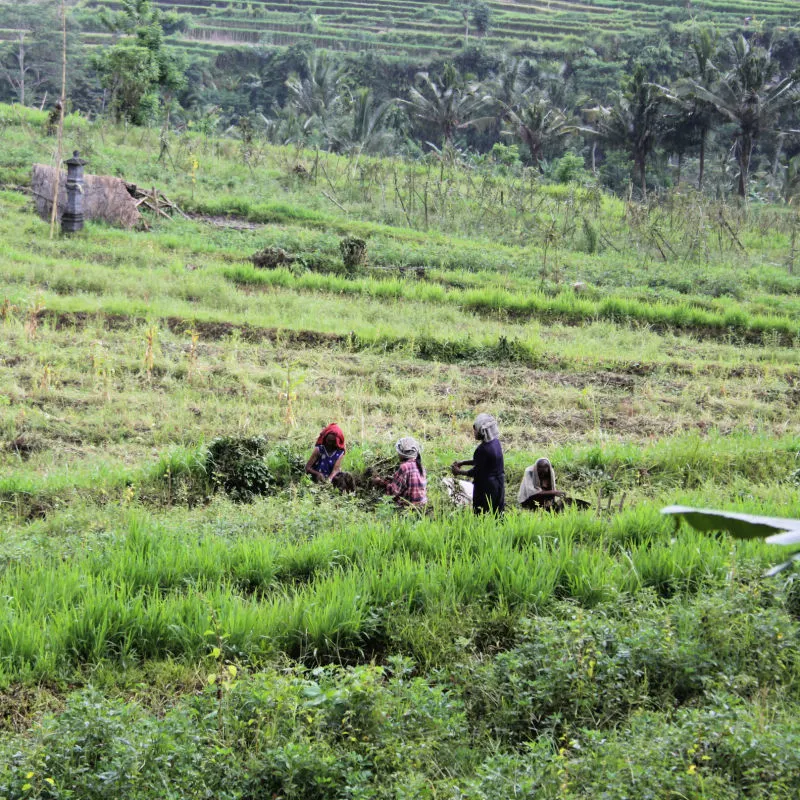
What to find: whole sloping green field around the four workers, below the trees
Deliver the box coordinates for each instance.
[0,107,800,800]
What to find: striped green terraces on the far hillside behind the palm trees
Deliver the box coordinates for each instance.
[56,0,797,57]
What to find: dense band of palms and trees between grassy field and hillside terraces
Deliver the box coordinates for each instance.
[0,0,800,200]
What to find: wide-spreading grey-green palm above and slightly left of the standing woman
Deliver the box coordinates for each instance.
[400,64,494,144]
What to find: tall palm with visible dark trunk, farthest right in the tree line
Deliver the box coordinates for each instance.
[694,36,798,197]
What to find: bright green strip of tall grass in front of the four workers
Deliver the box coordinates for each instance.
[0,508,780,681]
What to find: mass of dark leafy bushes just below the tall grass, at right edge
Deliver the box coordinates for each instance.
[463,587,798,741]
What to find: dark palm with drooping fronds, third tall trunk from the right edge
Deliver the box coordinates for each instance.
[581,64,663,198]
